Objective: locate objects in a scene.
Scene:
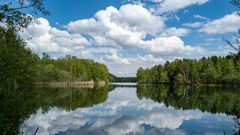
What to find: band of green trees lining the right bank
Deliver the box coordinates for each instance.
[137,54,240,84]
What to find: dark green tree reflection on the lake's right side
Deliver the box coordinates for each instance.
[137,85,240,135]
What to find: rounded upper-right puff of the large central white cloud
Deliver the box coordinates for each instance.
[113,4,165,34]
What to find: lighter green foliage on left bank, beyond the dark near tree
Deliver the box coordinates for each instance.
[35,53,109,82]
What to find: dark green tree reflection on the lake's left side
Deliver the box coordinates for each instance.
[0,86,114,135]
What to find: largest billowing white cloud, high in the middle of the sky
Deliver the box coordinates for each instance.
[66,4,165,48]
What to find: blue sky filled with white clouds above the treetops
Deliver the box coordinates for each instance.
[14,0,240,76]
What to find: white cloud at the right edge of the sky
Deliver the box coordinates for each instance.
[199,12,240,34]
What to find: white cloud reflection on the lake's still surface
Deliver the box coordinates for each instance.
[21,87,234,135]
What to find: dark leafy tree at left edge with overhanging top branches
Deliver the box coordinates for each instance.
[0,0,49,87]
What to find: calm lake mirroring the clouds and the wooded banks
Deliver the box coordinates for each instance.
[0,83,240,135]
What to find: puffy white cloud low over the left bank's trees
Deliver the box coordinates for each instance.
[20,18,90,53]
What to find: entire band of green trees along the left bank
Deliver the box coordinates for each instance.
[0,27,109,87]
